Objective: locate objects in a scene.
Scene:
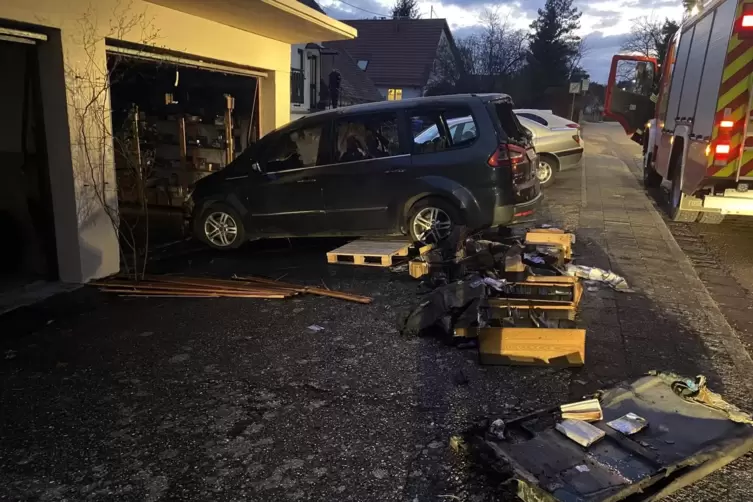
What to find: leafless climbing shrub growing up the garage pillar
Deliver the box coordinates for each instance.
[65,1,158,277]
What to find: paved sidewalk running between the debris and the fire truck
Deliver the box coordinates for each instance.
[544,124,753,500]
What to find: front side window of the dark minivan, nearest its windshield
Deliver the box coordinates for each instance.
[260,124,322,172]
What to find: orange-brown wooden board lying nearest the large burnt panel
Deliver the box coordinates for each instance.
[478,328,586,366]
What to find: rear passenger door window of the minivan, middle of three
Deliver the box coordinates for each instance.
[332,113,400,164]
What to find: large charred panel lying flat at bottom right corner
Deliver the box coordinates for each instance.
[469,373,753,502]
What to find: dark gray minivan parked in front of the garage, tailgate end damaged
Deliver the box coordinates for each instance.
[191,94,541,249]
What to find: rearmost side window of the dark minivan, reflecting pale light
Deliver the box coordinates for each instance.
[411,107,478,154]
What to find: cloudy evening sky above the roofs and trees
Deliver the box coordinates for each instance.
[318,0,682,82]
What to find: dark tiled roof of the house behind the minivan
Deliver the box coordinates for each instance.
[324,19,452,87]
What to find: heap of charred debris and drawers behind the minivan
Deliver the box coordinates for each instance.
[399,229,577,336]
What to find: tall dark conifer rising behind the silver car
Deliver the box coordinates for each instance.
[527,0,581,101]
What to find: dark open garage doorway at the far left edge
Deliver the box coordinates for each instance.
[0,31,58,294]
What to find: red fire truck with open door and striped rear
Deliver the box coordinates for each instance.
[605,0,753,223]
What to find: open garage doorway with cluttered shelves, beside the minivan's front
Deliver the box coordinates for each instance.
[107,47,260,246]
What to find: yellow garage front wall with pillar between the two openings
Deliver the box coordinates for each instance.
[0,0,328,282]
